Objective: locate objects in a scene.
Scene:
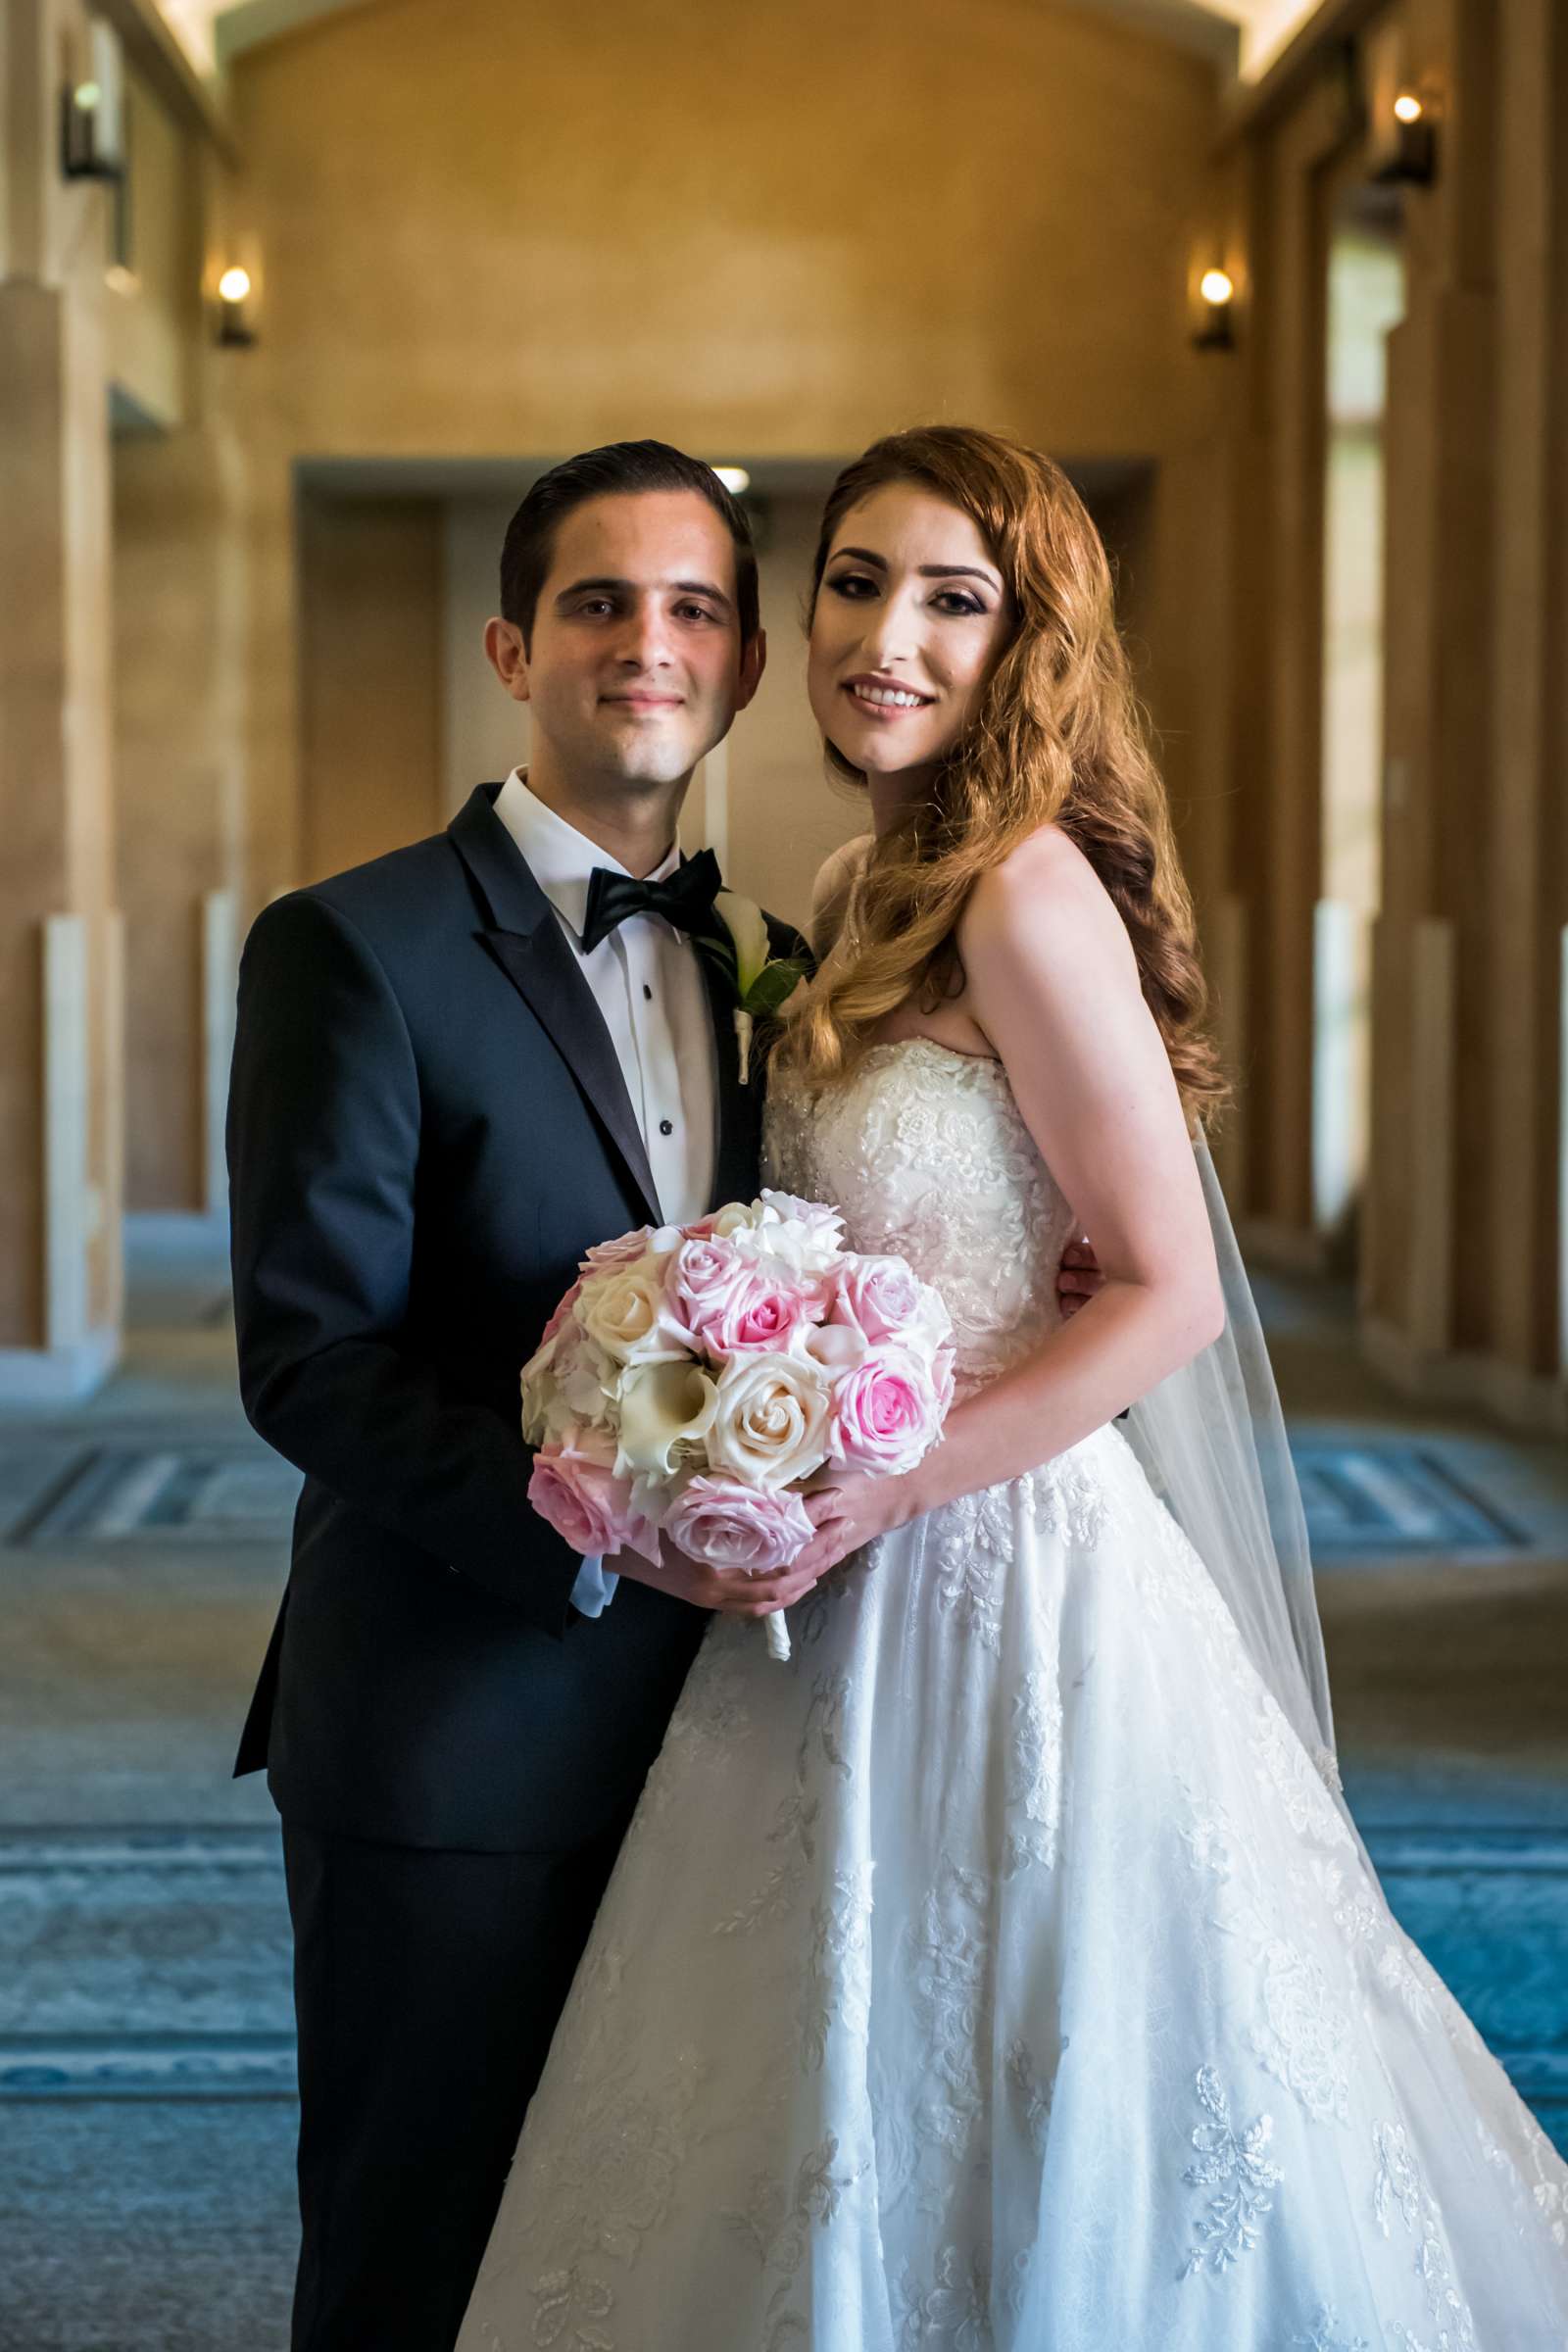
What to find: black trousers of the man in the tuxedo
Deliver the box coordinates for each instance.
[282,1823,625,2352]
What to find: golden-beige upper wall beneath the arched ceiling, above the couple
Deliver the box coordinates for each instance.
[235,0,1213,459]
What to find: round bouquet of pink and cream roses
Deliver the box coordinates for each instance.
[522,1190,953,1658]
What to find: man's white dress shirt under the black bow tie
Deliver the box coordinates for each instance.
[496,766,719,1616]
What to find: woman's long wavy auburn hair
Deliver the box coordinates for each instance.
[773,425,1227,1124]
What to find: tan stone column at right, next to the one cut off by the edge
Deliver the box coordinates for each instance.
[1361,0,1497,1386]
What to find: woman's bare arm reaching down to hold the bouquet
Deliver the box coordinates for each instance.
[802,830,1225,1566]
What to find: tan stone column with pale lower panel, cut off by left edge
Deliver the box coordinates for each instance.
[0,0,122,1401]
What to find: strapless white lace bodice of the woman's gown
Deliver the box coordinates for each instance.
[764,1037,1074,1378]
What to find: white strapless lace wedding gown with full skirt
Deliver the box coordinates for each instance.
[459,1040,1568,2352]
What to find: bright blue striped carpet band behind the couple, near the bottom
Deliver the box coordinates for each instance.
[0,1825,1568,2150]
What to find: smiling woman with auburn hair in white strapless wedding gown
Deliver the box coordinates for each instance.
[461,428,1568,2352]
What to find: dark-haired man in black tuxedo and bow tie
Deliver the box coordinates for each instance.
[228,442,827,2352]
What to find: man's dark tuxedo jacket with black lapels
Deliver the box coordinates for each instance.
[228,786,804,1851]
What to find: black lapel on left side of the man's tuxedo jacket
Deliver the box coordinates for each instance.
[447,783,662,1225]
